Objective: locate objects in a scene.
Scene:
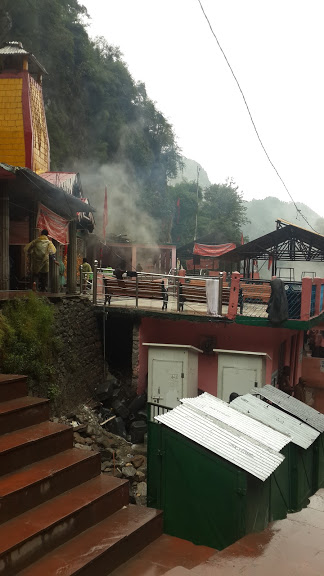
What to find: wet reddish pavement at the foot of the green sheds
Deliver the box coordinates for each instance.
[112,489,324,576]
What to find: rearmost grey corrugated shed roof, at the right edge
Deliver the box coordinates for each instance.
[251,384,324,432]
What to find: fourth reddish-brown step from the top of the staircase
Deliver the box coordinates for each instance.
[0,448,100,524]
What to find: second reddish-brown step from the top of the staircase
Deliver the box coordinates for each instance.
[0,392,49,434]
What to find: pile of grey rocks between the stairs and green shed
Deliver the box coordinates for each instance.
[53,401,147,506]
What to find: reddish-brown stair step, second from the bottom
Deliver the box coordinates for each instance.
[0,475,129,576]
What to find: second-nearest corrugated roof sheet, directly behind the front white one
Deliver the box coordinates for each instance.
[181,392,290,452]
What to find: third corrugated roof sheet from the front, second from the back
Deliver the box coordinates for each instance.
[231,394,319,449]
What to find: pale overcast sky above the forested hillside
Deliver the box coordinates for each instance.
[80,0,324,217]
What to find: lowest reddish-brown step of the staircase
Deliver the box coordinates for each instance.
[16,504,162,576]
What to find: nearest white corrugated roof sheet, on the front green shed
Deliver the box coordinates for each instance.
[155,404,284,482]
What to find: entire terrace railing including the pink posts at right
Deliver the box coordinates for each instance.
[84,266,324,321]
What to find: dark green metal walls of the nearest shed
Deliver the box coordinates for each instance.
[148,422,272,550]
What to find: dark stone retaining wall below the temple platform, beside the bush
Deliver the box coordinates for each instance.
[53,297,104,413]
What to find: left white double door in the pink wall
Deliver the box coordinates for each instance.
[143,342,202,408]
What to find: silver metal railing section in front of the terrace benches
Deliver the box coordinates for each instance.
[90,262,229,315]
